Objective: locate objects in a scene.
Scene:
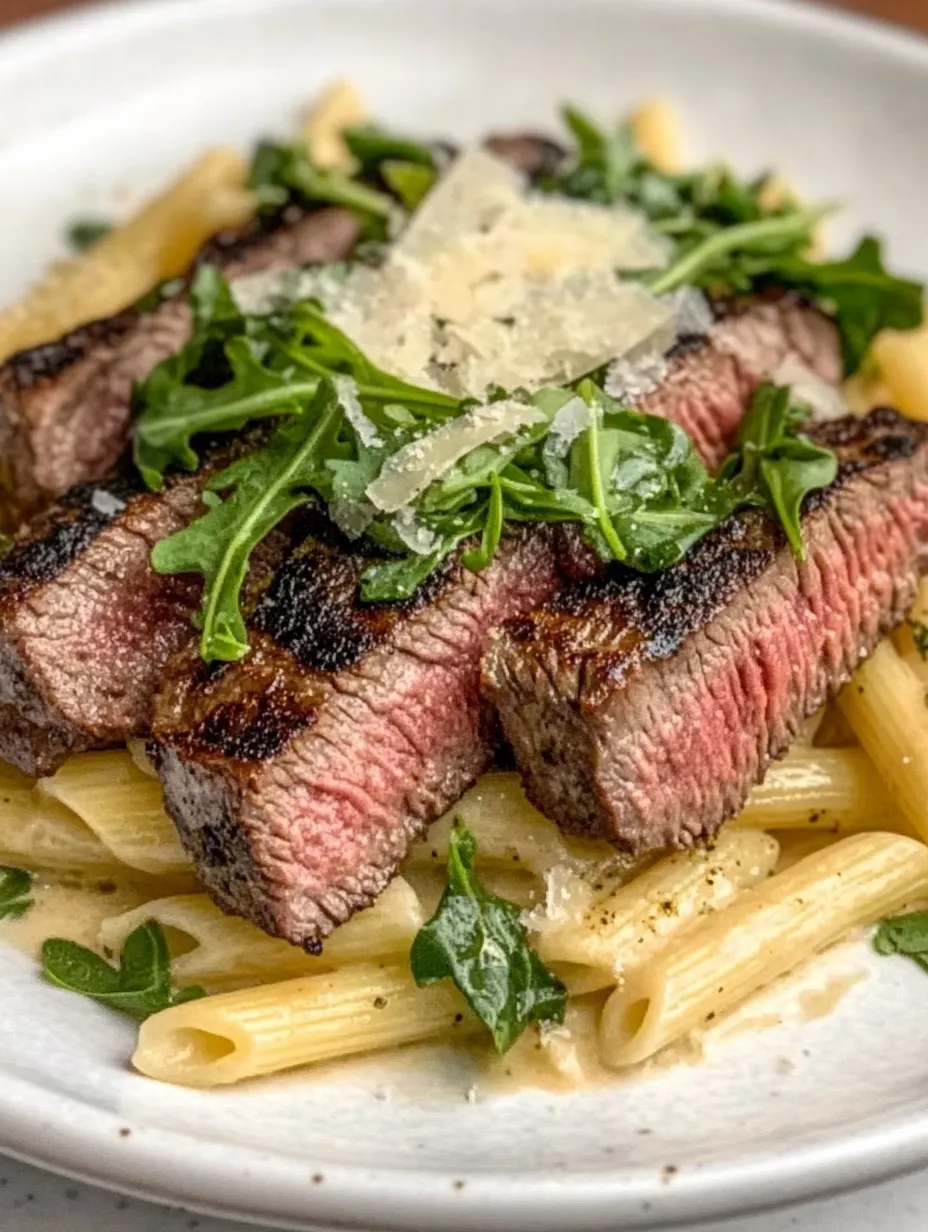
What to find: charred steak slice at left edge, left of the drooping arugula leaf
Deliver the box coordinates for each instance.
[0,435,290,775]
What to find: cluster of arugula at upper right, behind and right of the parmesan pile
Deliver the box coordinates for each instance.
[545,108,924,376]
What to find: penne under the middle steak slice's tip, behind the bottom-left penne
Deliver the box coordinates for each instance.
[100,877,425,987]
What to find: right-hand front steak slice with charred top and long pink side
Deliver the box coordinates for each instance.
[483,409,928,853]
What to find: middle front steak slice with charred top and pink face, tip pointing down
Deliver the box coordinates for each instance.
[150,527,562,950]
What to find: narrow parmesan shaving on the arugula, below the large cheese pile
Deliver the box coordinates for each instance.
[367,400,545,514]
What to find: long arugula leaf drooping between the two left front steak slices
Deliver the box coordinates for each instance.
[152,379,341,663]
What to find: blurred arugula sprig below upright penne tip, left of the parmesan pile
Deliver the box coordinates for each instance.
[248,142,393,221]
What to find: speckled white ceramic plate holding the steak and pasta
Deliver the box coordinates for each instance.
[0,0,928,1232]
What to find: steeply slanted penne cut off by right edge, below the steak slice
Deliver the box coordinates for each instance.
[838,639,928,838]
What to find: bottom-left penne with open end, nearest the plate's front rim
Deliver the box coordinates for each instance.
[132,963,603,1087]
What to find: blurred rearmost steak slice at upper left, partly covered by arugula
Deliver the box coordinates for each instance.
[0,209,359,529]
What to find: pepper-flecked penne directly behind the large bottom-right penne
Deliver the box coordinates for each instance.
[529,827,779,975]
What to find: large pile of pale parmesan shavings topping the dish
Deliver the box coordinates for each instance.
[235,149,683,399]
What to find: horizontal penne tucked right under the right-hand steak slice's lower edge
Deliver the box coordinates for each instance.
[735,745,910,833]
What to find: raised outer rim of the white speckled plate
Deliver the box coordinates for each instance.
[0,0,928,1232]
